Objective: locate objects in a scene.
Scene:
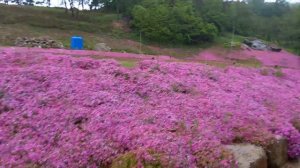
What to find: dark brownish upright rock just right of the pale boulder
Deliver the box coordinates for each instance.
[266,136,288,168]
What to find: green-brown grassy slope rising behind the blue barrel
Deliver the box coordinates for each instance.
[0,4,206,57]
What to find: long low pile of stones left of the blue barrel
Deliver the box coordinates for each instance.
[15,37,64,48]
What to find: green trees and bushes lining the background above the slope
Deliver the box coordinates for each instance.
[3,0,300,53]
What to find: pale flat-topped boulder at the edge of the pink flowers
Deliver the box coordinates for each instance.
[226,144,267,168]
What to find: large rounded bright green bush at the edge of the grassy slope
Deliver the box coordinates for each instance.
[132,1,218,44]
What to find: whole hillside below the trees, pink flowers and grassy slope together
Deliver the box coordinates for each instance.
[0,0,300,168]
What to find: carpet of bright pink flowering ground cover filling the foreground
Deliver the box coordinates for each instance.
[0,48,300,167]
